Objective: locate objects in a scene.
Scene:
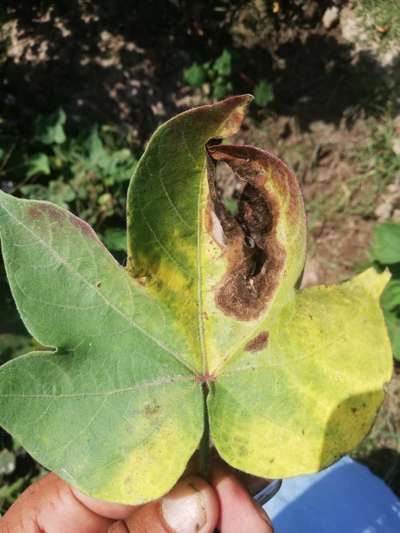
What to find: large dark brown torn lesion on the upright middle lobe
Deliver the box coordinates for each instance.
[207,144,285,320]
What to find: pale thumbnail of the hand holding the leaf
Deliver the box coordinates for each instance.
[161,479,207,533]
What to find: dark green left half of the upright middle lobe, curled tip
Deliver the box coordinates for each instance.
[128,96,251,373]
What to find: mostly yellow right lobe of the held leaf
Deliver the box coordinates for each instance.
[209,269,392,478]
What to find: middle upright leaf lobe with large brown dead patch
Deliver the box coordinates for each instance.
[128,96,305,375]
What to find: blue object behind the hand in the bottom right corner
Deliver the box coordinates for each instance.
[264,457,400,533]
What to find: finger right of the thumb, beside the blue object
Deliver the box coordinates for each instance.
[212,468,273,533]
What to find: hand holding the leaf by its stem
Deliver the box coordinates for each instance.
[0,469,273,533]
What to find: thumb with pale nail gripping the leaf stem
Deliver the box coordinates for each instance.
[108,477,219,533]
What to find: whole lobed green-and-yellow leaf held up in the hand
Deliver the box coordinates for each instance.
[0,96,392,503]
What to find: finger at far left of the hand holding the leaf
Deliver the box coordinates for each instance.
[0,474,134,533]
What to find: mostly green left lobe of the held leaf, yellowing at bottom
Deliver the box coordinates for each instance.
[0,192,203,502]
